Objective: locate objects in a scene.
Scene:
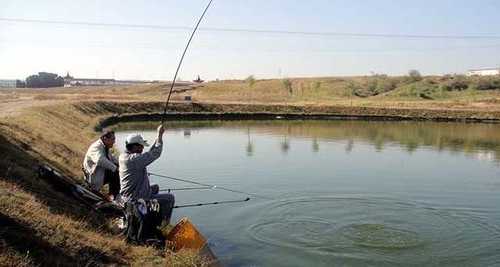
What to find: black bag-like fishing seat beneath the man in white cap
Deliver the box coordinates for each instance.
[125,199,165,245]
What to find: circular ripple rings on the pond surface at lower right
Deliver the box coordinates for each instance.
[247,196,500,264]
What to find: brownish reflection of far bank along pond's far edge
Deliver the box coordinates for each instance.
[112,121,500,161]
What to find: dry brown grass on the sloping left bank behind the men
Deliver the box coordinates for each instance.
[0,101,202,266]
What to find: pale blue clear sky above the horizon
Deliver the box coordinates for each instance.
[0,0,500,80]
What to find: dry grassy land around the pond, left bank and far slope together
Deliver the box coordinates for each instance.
[0,76,500,265]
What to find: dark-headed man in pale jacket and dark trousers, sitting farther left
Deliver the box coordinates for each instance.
[83,129,120,200]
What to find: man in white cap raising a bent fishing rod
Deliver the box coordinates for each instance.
[119,125,175,223]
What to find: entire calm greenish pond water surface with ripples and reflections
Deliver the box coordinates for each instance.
[117,121,500,266]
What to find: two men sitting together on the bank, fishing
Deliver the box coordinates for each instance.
[83,125,175,223]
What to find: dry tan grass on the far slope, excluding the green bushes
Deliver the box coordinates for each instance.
[190,77,500,110]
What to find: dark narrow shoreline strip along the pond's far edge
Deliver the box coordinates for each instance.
[94,103,500,131]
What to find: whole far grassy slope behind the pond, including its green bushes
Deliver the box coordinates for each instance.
[194,75,500,110]
